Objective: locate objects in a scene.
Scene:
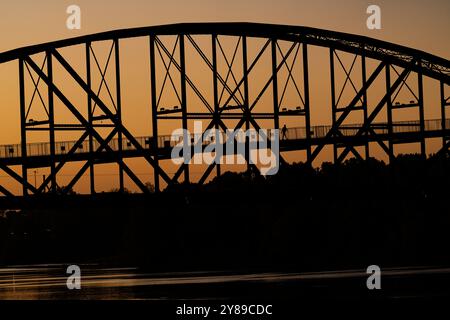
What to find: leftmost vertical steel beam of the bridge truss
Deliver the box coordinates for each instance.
[19,58,28,197]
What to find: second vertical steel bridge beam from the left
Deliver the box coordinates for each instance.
[46,51,57,193]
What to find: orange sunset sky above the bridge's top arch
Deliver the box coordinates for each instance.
[0,0,450,57]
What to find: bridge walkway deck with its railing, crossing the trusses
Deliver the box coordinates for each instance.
[0,119,450,168]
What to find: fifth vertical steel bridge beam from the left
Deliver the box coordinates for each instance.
[150,34,159,192]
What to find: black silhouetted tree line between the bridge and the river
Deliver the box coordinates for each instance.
[0,155,450,271]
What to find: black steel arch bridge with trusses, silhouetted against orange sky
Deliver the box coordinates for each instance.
[0,23,450,195]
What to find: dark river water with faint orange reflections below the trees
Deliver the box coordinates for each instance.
[0,265,450,300]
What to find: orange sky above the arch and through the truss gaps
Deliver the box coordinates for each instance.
[0,0,450,192]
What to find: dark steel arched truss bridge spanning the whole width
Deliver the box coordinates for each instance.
[0,23,450,196]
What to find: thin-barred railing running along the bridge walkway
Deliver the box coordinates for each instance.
[0,119,450,158]
